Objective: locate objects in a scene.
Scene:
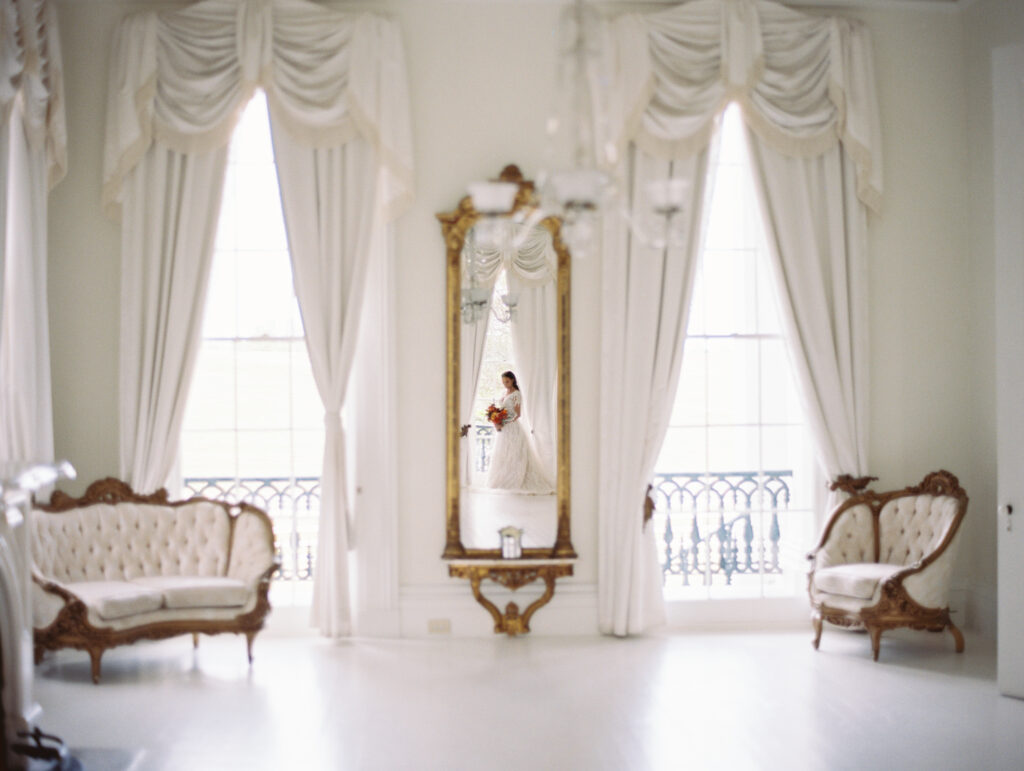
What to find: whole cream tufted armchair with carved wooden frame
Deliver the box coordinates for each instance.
[808,471,968,660]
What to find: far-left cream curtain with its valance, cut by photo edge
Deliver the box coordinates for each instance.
[0,0,67,461]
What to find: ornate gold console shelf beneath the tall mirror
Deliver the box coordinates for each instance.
[449,559,572,637]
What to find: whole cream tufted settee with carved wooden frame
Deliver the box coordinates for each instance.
[32,478,278,683]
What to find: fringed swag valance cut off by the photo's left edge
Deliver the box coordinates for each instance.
[0,0,68,187]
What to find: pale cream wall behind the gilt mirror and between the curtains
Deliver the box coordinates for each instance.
[50,0,998,635]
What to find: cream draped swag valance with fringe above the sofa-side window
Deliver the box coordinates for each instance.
[102,0,413,220]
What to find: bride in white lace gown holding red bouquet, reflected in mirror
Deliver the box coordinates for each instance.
[487,372,554,495]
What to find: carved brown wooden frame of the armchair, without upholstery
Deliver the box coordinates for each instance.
[807,471,968,661]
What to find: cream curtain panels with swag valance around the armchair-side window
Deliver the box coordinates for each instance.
[597,0,882,635]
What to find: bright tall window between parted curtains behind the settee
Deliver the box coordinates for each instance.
[180,92,324,583]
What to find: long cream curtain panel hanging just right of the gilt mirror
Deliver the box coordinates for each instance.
[598,143,711,636]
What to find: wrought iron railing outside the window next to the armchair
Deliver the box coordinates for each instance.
[651,471,793,586]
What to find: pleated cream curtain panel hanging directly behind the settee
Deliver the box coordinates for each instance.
[120,145,227,492]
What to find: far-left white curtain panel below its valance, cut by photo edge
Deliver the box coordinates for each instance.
[0,98,53,461]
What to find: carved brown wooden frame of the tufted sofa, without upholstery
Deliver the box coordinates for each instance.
[32,478,281,683]
